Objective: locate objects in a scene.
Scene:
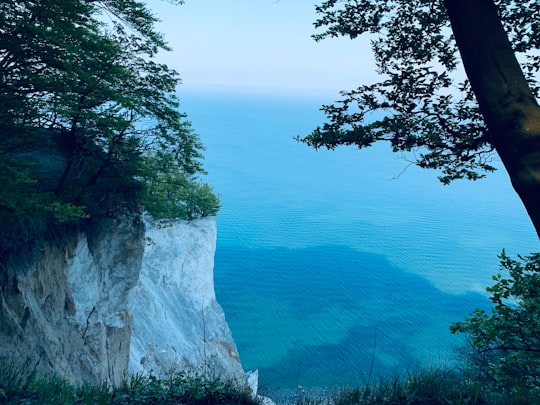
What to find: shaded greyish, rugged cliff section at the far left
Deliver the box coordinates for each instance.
[0,213,144,384]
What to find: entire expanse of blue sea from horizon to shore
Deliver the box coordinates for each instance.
[180,87,539,390]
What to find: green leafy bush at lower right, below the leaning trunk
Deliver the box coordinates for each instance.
[450,251,540,389]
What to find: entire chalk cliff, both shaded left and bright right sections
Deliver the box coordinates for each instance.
[0,212,243,384]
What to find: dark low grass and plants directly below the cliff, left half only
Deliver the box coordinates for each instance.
[0,366,259,405]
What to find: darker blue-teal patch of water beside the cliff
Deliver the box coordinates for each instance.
[215,244,488,389]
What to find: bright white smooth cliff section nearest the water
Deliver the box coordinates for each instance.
[129,217,245,382]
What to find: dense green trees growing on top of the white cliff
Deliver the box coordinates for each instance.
[0,0,219,248]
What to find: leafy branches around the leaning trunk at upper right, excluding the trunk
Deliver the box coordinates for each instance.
[301,0,540,184]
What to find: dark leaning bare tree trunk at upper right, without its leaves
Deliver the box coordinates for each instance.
[445,0,540,237]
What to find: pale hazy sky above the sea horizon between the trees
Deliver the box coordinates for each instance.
[149,0,374,94]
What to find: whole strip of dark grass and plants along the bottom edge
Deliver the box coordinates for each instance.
[0,367,540,405]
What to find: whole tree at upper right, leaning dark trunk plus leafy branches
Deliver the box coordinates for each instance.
[301,0,540,236]
